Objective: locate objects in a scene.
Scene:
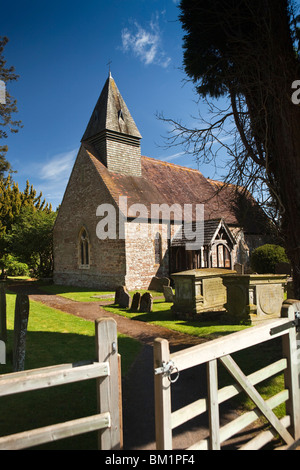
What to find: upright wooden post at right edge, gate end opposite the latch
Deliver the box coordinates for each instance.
[281,300,300,441]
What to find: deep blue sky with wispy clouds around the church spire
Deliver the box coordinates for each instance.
[1,0,220,207]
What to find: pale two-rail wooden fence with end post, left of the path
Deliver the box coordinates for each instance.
[0,319,122,450]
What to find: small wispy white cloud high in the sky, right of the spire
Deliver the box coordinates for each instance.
[121,15,171,68]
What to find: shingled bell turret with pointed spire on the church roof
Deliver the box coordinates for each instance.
[81,74,142,176]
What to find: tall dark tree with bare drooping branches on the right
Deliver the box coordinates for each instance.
[173,0,300,298]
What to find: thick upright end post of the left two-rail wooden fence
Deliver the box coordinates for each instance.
[95,318,122,450]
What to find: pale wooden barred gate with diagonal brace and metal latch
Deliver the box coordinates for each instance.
[154,301,300,450]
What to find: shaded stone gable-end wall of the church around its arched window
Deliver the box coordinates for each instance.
[53,148,126,290]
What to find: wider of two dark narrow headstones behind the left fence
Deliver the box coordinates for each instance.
[13,294,29,372]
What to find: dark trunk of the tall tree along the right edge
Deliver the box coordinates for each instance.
[237,0,300,299]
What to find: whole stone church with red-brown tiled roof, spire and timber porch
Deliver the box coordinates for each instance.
[53,74,266,290]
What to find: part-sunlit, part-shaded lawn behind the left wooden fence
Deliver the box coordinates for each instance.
[0,293,141,450]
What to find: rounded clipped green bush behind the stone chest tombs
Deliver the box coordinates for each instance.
[251,245,289,274]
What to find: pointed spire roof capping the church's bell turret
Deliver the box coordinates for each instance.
[82,75,142,141]
